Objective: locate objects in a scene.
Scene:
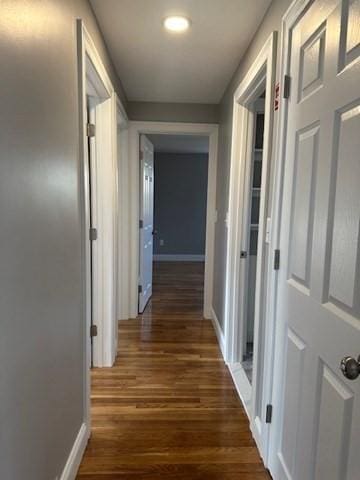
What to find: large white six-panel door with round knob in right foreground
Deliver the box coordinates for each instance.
[274,0,360,480]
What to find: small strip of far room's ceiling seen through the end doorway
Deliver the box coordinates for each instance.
[146,134,209,153]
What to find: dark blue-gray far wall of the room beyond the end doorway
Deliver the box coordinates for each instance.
[154,153,208,255]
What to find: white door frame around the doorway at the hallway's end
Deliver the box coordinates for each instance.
[129,121,218,319]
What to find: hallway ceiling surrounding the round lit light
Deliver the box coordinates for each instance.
[90,0,271,103]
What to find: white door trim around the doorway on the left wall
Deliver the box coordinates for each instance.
[77,20,117,378]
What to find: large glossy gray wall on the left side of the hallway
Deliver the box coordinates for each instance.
[0,0,122,480]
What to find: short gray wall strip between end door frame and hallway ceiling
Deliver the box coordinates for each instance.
[128,102,219,123]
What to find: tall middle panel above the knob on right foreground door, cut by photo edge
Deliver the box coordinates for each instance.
[328,104,360,316]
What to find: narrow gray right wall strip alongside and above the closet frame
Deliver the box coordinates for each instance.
[213,0,291,327]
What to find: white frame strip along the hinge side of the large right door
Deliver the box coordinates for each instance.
[266,0,315,472]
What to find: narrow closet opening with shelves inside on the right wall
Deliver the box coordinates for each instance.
[230,81,270,417]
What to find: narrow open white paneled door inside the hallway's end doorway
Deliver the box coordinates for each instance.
[139,135,154,313]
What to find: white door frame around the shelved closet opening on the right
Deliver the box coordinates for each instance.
[225,32,277,464]
